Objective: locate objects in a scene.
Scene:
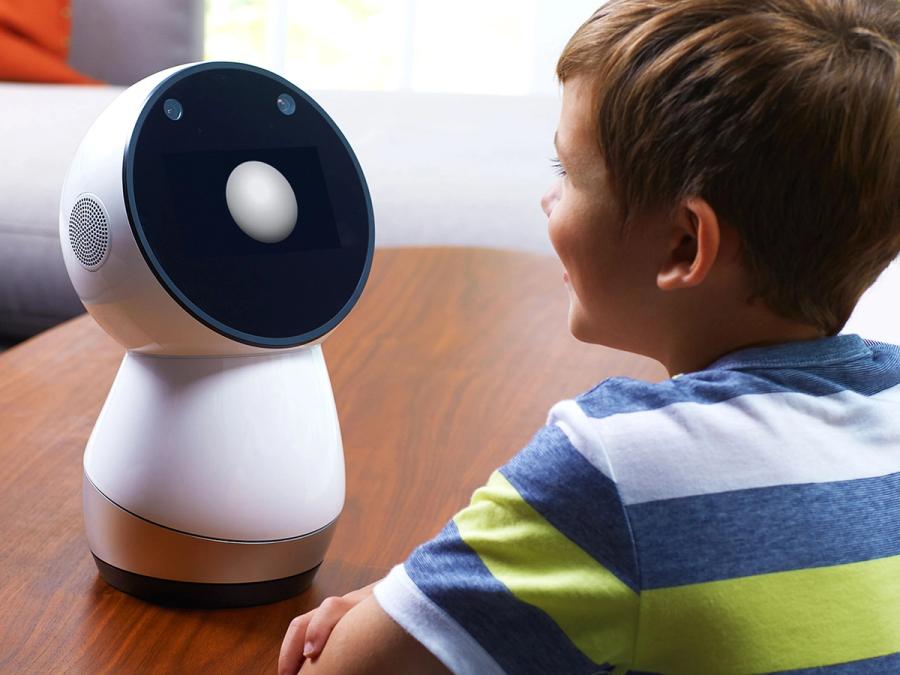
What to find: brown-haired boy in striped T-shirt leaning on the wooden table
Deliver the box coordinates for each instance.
[279,0,900,675]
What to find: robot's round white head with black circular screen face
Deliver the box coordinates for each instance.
[60,62,374,355]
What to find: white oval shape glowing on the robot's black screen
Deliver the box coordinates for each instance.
[225,161,297,244]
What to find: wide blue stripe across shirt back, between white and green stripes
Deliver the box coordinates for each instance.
[626,473,900,589]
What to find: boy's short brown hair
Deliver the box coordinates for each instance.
[557,0,900,335]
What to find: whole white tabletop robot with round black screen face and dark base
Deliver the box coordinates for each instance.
[59,62,374,607]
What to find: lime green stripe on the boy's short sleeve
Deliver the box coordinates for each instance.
[453,471,638,663]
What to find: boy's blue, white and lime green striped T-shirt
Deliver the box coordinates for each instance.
[374,334,900,675]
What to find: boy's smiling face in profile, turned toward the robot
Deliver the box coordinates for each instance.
[541,76,661,353]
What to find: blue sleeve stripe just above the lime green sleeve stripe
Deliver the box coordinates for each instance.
[499,425,639,592]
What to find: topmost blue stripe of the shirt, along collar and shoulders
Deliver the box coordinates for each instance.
[575,335,900,419]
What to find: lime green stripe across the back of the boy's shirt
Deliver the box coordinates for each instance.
[633,556,900,673]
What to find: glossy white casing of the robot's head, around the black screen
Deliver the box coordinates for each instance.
[59,63,371,356]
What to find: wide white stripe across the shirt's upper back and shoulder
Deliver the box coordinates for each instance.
[554,385,900,504]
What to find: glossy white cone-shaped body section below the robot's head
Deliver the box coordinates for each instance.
[84,346,344,541]
